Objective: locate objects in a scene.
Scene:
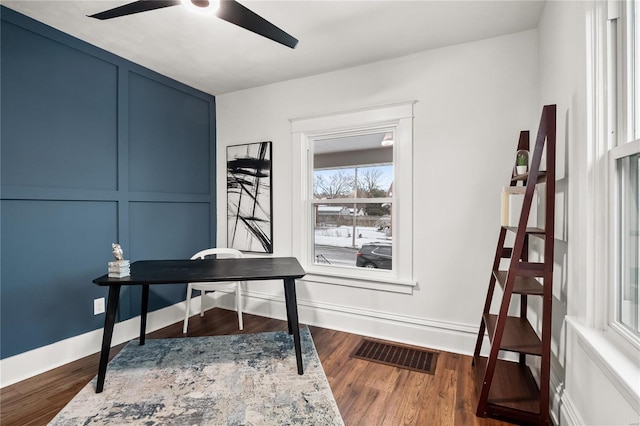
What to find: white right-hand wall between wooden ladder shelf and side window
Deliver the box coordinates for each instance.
[538,1,640,425]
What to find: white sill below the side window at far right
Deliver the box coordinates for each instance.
[566,317,640,407]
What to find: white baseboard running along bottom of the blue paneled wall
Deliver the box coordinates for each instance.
[0,298,190,388]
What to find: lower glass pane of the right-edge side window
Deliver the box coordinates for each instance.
[618,154,640,334]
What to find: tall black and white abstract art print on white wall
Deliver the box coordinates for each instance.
[227,142,273,253]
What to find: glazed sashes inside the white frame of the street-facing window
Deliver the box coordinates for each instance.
[308,128,394,270]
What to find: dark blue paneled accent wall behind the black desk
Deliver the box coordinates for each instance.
[0,6,216,358]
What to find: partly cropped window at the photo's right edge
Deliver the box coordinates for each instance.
[608,2,640,345]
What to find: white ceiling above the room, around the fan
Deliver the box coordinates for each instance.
[1,0,544,95]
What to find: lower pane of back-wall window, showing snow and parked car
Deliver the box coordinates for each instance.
[311,203,393,269]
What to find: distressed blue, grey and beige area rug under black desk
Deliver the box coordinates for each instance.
[49,327,344,426]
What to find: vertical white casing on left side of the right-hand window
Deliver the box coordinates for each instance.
[584,1,635,338]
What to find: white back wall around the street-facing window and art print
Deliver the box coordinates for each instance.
[216,30,540,354]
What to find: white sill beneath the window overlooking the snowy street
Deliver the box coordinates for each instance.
[299,266,417,294]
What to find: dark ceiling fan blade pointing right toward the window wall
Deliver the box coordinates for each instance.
[216,0,298,49]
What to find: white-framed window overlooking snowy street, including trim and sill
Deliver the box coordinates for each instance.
[291,102,415,293]
